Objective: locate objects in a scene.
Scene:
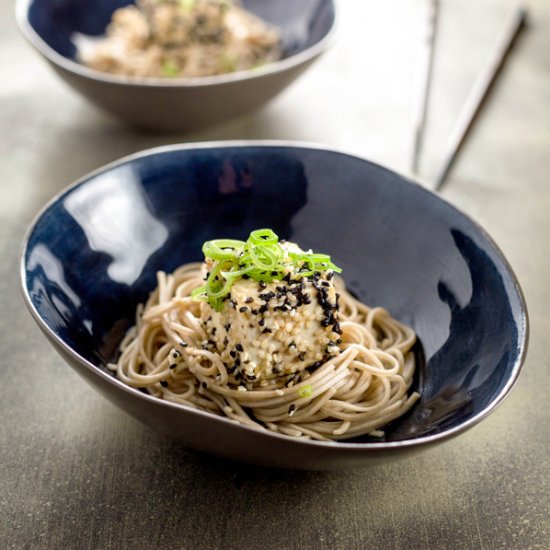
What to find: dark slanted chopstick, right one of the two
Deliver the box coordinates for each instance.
[434,5,527,191]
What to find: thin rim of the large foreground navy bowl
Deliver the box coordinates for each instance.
[19,139,530,454]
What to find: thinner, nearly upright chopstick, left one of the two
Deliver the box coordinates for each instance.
[411,0,439,174]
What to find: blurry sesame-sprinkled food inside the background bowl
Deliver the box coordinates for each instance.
[77,0,282,77]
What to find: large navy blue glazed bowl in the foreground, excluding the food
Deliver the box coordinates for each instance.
[21,142,528,469]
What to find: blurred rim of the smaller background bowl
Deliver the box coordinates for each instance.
[15,0,339,88]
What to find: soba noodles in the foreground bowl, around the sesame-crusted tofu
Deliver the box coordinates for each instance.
[110,263,419,440]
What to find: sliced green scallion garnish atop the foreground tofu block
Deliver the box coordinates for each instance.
[192,229,342,311]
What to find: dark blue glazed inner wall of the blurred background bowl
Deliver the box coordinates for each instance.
[28,0,334,59]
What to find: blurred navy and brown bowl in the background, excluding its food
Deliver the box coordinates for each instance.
[16,0,335,131]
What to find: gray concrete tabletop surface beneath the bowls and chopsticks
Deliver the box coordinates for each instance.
[0,0,550,550]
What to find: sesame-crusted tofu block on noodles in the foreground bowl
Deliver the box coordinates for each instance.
[202,271,341,381]
